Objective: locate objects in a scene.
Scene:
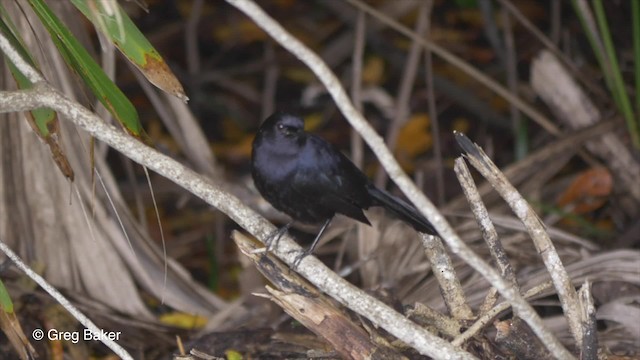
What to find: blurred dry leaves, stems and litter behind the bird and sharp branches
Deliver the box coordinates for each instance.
[0,0,640,359]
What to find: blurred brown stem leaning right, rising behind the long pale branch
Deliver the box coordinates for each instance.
[376,2,429,188]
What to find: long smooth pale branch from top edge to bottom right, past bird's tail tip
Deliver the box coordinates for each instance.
[227,0,574,359]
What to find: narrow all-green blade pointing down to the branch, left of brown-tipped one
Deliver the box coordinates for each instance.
[28,0,143,138]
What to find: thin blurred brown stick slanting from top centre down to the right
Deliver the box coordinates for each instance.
[346,0,560,136]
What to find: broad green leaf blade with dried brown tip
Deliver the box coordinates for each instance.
[71,0,187,100]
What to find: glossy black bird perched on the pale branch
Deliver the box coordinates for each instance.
[251,112,436,264]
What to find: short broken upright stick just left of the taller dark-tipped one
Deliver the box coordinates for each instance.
[453,158,520,310]
